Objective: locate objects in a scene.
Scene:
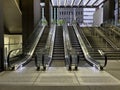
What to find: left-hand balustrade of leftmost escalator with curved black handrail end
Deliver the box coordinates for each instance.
[6,21,46,70]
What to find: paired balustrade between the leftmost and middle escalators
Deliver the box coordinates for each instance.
[35,24,56,71]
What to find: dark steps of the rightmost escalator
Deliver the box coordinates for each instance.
[68,26,88,66]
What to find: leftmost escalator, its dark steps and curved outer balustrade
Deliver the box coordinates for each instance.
[7,26,49,70]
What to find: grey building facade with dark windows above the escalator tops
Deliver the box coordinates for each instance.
[57,8,83,25]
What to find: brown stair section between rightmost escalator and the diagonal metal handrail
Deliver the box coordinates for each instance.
[81,27,114,61]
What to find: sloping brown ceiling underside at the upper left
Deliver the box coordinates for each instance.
[3,0,22,34]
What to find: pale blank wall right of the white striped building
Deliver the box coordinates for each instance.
[93,8,103,26]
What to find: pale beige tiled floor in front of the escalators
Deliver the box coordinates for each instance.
[0,61,120,90]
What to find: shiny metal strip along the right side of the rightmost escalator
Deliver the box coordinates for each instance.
[73,24,103,70]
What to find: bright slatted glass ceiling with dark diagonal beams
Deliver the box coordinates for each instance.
[51,0,107,8]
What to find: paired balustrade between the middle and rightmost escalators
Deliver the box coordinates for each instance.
[63,24,78,70]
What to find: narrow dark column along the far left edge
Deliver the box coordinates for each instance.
[0,0,4,71]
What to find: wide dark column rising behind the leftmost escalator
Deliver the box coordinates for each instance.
[21,0,41,44]
